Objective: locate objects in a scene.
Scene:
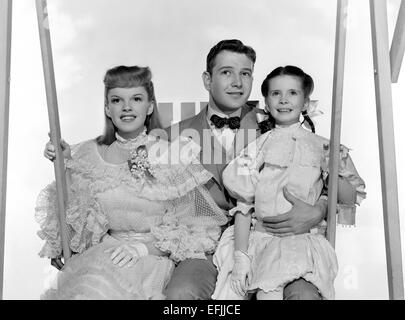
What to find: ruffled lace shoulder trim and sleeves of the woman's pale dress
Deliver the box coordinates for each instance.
[36,140,227,261]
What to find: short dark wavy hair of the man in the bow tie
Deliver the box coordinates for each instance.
[206,39,256,74]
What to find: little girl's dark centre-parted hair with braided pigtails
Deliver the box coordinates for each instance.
[260,66,315,133]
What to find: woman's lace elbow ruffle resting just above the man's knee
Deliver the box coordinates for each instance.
[151,223,220,262]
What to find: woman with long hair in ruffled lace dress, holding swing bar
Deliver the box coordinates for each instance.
[36,66,227,300]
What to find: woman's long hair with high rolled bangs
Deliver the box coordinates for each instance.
[97,66,162,145]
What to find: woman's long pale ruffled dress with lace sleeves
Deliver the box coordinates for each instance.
[36,136,227,299]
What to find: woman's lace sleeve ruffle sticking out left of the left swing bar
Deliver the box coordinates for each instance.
[35,182,62,258]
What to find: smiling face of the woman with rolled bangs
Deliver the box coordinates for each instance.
[105,87,154,139]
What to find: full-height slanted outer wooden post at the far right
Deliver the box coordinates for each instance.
[370,0,404,300]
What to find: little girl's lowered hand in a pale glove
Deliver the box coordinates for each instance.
[230,250,251,296]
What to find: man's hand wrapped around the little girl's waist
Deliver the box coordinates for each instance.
[263,187,326,237]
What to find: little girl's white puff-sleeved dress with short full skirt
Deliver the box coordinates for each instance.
[212,123,365,299]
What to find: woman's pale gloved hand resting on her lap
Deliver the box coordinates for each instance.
[104,242,148,268]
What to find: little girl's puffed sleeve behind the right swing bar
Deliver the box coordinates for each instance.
[322,145,366,225]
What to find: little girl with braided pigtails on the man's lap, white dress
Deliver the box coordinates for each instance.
[213,66,365,300]
